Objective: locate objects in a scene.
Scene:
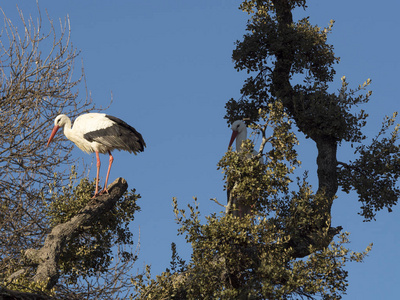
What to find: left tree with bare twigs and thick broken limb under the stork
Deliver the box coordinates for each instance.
[0,5,140,299]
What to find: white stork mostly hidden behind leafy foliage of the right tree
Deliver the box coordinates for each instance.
[227,120,262,217]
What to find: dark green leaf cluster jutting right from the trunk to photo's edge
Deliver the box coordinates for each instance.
[339,114,400,221]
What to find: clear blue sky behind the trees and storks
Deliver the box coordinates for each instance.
[0,0,400,299]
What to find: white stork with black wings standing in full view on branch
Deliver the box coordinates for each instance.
[47,113,146,197]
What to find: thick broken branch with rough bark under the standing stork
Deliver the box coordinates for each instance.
[25,178,128,289]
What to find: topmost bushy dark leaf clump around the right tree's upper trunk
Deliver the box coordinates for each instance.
[232,14,338,84]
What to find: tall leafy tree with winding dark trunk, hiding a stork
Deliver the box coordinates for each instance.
[130,0,399,299]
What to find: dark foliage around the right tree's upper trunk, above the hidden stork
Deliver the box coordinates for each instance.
[225,1,370,146]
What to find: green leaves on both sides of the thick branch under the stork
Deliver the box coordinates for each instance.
[45,168,140,283]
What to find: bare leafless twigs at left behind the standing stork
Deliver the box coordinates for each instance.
[0,2,94,277]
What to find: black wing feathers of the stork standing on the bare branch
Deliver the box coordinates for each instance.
[83,115,146,153]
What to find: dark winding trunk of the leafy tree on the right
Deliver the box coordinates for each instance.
[271,0,341,257]
